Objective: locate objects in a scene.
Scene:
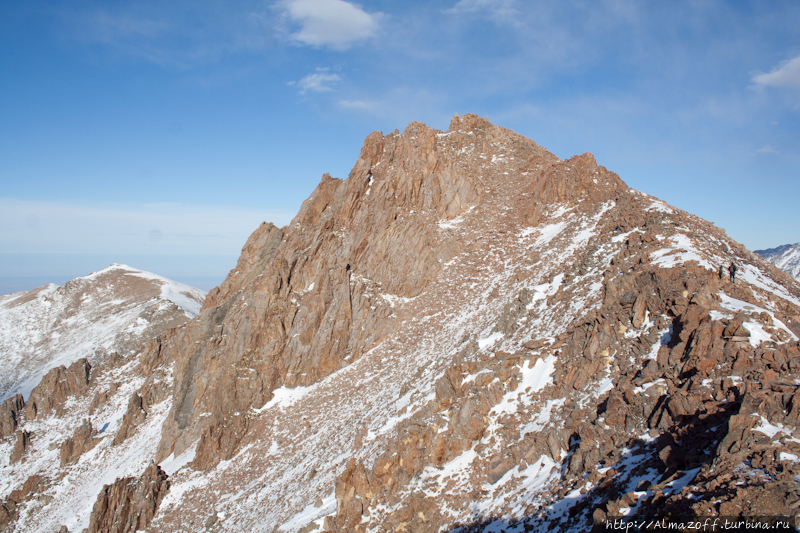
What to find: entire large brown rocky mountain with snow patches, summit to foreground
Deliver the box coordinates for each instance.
[0,115,800,533]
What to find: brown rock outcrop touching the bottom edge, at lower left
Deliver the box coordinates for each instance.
[87,464,169,533]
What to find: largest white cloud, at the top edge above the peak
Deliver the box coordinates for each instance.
[280,0,381,50]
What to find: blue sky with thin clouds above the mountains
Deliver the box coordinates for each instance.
[0,0,800,293]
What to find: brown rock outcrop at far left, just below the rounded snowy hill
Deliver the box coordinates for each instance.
[25,358,92,420]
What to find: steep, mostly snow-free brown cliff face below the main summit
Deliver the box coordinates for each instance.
[153,111,624,468]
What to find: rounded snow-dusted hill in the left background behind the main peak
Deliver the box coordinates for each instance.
[0,264,205,400]
